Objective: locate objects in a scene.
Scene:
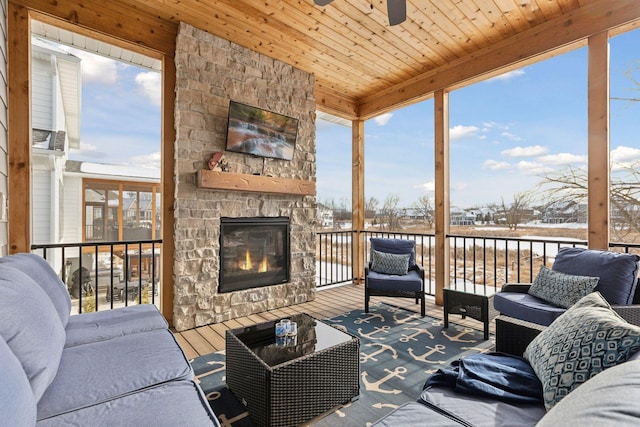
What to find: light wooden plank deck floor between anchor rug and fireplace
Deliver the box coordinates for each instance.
[175,284,494,359]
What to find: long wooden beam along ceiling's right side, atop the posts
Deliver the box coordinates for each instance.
[358,0,640,119]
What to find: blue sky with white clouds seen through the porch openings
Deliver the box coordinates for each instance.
[60,30,640,207]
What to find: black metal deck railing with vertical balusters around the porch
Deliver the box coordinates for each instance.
[31,234,640,313]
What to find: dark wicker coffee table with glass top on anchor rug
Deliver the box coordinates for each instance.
[226,314,360,427]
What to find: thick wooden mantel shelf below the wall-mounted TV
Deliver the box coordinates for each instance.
[196,169,316,196]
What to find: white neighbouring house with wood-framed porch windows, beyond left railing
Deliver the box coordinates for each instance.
[31,37,160,284]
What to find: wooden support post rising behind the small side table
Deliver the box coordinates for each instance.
[434,90,450,305]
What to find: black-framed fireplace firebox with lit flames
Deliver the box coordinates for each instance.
[218,217,289,293]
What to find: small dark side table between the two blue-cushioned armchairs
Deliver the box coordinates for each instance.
[443,288,498,340]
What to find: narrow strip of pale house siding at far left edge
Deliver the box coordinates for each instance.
[0,0,9,256]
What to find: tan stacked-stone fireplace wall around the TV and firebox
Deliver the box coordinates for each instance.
[173,23,317,330]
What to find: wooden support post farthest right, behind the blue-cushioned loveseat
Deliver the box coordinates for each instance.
[588,32,610,250]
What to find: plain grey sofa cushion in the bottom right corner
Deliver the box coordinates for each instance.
[538,361,640,427]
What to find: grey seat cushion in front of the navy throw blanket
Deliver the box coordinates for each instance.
[418,386,546,427]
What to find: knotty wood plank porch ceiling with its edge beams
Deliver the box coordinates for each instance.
[22,0,640,119]
